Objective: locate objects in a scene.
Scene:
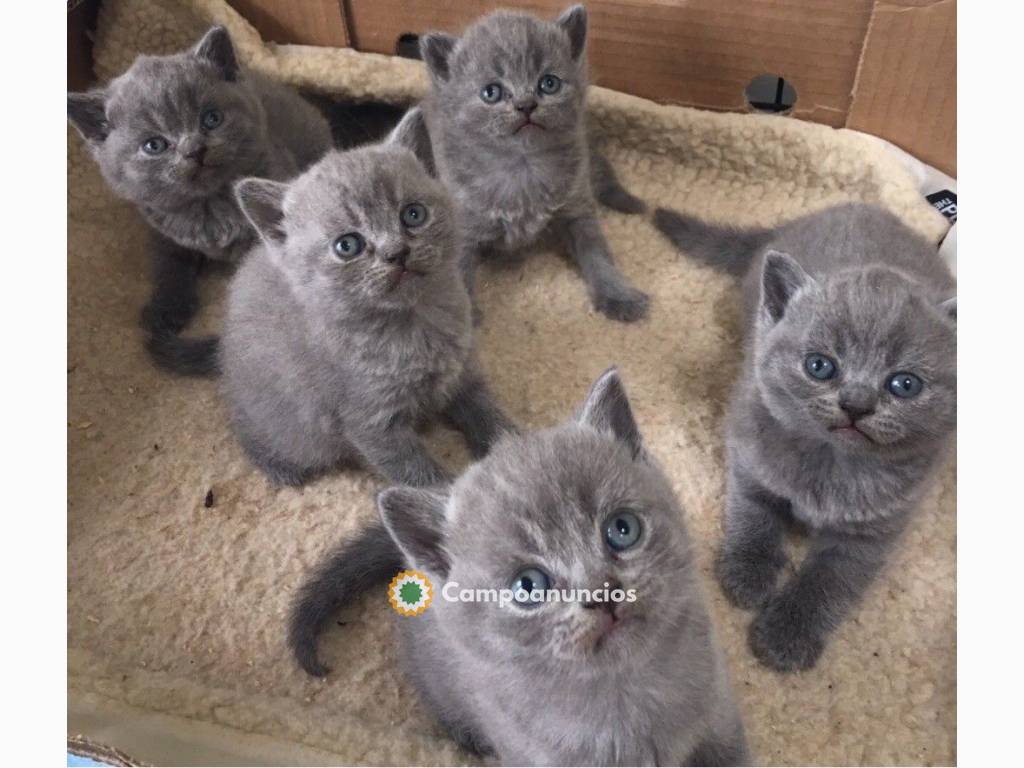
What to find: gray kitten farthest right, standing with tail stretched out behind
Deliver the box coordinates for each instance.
[655,204,956,671]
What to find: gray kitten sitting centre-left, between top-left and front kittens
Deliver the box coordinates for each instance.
[219,110,514,485]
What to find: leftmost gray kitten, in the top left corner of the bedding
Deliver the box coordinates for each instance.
[68,27,331,374]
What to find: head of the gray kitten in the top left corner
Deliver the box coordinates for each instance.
[69,28,266,208]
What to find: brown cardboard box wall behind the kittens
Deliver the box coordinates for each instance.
[230,0,956,175]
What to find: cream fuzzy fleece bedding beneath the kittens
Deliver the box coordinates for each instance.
[68,0,956,764]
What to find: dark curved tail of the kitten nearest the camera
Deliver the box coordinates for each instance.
[288,522,404,677]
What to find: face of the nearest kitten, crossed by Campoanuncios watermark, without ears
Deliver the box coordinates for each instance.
[444,426,689,672]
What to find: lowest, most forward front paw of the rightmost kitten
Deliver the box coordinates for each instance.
[750,597,825,672]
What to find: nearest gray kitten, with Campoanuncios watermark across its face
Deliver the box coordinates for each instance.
[290,370,750,765]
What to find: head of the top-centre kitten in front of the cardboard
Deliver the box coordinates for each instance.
[425,8,587,148]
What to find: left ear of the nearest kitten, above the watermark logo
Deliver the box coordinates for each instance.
[377,485,451,578]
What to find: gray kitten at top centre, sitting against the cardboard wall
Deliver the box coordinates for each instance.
[420,5,647,321]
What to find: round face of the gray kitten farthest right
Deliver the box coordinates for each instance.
[757,268,956,453]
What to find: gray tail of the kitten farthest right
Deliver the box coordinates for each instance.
[654,208,774,274]
